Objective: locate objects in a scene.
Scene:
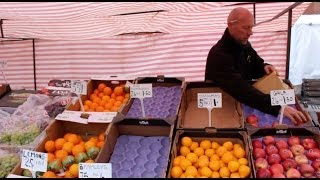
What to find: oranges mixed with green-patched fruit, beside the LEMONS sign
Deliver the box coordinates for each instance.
[41,133,105,178]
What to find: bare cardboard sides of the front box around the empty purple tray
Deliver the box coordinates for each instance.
[96,123,174,178]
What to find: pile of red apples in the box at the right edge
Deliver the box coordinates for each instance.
[252,136,320,178]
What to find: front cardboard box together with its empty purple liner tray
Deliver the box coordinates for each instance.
[97,122,174,178]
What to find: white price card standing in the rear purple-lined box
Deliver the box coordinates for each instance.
[130,84,152,98]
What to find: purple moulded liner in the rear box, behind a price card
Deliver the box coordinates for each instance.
[126,86,182,118]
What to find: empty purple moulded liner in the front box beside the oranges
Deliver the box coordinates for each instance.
[110,135,170,178]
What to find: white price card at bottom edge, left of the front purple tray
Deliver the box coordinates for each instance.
[79,163,112,178]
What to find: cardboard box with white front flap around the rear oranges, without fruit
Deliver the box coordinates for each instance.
[56,76,135,124]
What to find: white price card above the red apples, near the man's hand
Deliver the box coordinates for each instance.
[270,89,296,106]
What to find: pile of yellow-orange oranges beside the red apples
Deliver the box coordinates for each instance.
[170,136,250,178]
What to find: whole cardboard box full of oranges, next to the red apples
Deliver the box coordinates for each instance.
[167,129,252,178]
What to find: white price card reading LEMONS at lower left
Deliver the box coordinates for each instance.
[21,149,48,172]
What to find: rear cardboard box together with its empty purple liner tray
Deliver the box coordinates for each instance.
[118,76,185,125]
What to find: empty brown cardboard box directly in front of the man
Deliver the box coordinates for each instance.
[177,82,244,130]
